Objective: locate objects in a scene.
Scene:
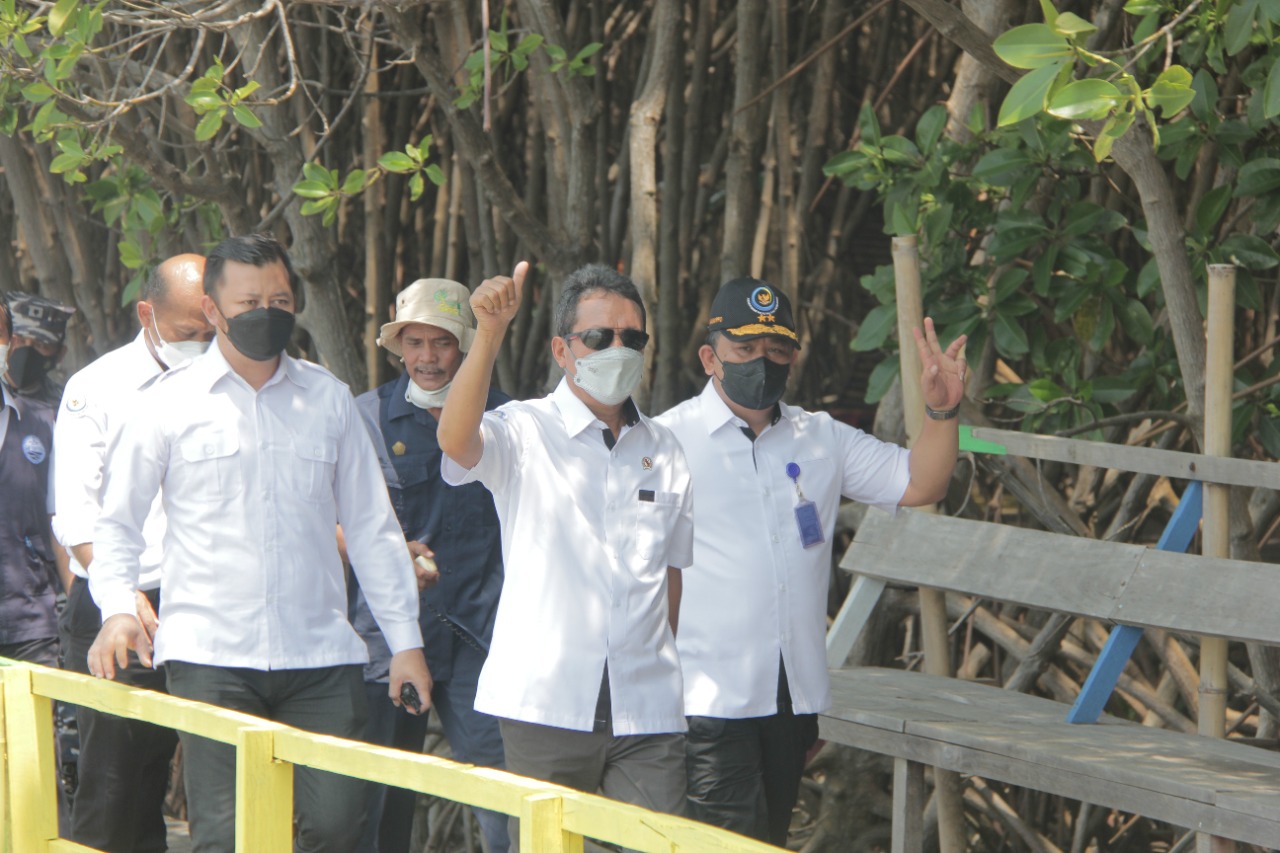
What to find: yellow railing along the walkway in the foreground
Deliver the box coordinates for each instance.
[0,658,777,853]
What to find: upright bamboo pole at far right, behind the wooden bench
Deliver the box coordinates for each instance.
[1196,264,1235,853]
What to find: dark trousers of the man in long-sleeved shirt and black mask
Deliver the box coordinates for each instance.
[165,661,367,853]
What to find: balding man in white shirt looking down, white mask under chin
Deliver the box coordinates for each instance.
[54,255,214,853]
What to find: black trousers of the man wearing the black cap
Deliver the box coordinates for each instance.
[685,671,818,847]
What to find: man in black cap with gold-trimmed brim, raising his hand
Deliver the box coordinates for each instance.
[657,278,965,847]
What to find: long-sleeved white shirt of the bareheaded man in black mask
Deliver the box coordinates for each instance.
[90,341,422,670]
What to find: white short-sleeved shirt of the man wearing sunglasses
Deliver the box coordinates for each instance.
[442,380,694,735]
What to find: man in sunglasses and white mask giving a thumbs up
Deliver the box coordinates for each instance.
[438,263,692,839]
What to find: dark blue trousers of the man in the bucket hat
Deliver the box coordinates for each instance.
[357,643,509,853]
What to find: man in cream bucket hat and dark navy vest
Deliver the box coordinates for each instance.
[352,278,509,853]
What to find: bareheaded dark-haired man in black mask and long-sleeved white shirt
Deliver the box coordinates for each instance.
[88,234,431,853]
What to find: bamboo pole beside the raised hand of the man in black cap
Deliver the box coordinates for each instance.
[893,234,965,853]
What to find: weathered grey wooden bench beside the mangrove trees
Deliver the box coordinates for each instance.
[820,510,1280,852]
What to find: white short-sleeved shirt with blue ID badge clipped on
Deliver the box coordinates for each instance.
[657,382,910,719]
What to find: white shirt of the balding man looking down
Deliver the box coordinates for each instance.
[54,332,164,589]
